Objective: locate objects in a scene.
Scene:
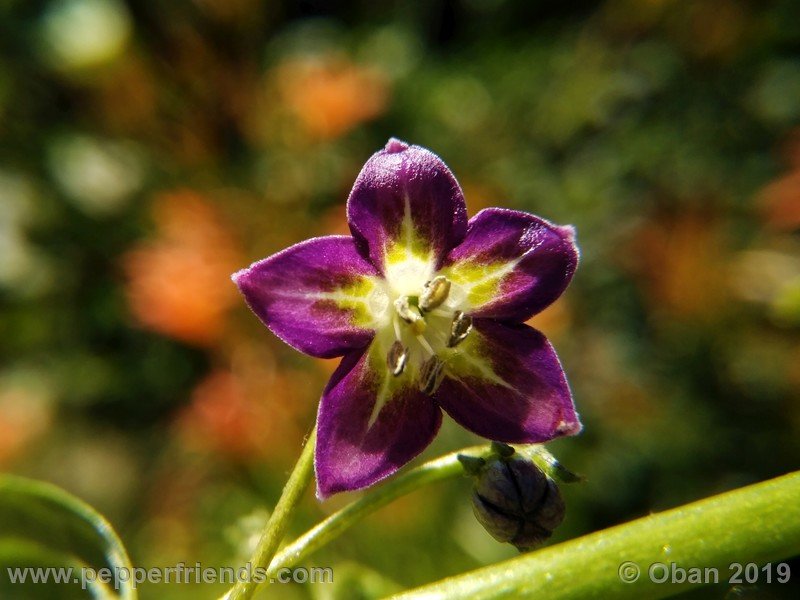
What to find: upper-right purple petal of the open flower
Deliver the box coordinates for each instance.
[442,208,578,321]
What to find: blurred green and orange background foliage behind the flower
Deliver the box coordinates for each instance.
[0,0,800,599]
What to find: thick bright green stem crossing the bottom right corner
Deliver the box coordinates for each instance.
[393,471,800,600]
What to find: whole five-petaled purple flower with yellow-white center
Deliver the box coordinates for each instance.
[233,139,581,498]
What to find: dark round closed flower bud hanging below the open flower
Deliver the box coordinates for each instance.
[472,454,565,552]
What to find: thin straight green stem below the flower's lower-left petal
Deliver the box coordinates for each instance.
[224,426,317,600]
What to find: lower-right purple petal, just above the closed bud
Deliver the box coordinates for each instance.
[434,319,581,443]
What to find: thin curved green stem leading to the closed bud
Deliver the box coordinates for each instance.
[269,444,491,577]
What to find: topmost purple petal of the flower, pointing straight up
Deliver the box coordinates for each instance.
[347,139,467,272]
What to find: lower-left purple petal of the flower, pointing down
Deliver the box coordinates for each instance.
[315,345,442,499]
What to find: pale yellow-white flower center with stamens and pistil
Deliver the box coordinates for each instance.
[383,275,472,394]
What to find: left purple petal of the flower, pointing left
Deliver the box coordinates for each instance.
[233,236,389,358]
